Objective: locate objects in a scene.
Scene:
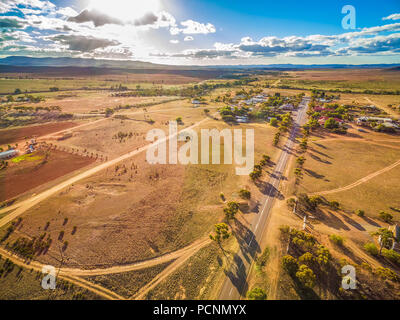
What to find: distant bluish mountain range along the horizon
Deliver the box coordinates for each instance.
[0,56,400,71]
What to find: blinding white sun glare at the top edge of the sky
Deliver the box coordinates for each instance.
[89,0,161,21]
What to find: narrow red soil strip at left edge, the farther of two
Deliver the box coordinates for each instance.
[0,122,77,145]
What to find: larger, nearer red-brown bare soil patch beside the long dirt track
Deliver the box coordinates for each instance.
[0,150,95,201]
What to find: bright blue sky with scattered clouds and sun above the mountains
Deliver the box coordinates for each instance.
[0,0,400,65]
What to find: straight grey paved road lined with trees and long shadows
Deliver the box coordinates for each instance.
[220,97,310,300]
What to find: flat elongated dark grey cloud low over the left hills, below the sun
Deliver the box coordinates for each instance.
[50,35,120,52]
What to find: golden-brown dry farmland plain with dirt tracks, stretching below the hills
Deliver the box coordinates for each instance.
[0,65,400,299]
